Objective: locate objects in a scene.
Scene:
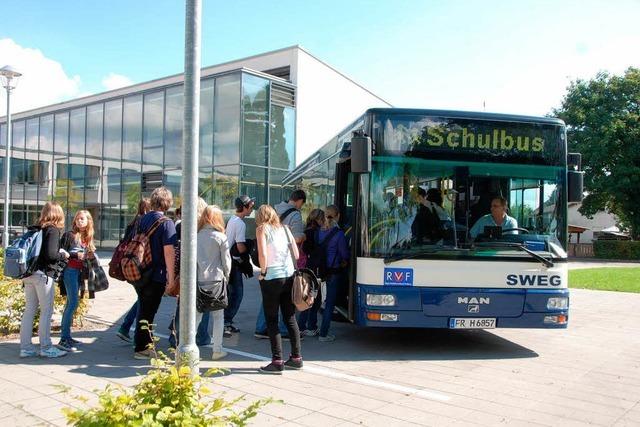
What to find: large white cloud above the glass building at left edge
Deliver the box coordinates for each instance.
[0,38,81,116]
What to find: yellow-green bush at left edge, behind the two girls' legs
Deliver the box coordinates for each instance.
[0,252,89,336]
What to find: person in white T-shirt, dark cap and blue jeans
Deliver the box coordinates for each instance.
[224,194,256,337]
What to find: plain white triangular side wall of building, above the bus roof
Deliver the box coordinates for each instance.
[292,49,391,165]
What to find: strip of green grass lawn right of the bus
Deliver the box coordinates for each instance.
[569,267,640,293]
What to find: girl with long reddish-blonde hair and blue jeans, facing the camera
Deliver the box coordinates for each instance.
[58,210,96,352]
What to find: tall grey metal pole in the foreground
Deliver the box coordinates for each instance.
[176,0,202,375]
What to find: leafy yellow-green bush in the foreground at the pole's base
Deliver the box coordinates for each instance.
[63,326,272,427]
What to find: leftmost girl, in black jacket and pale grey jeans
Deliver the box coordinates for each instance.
[20,202,69,357]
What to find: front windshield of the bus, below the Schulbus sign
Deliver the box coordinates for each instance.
[366,155,566,258]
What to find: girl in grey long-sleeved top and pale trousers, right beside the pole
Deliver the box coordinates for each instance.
[196,206,231,360]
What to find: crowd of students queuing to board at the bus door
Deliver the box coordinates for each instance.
[112,187,348,374]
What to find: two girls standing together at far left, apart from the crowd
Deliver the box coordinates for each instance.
[20,202,96,358]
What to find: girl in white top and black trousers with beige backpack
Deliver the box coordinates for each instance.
[256,205,302,375]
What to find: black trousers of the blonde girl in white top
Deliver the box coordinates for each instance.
[260,277,300,360]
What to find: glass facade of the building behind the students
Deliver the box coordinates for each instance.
[0,69,296,248]
